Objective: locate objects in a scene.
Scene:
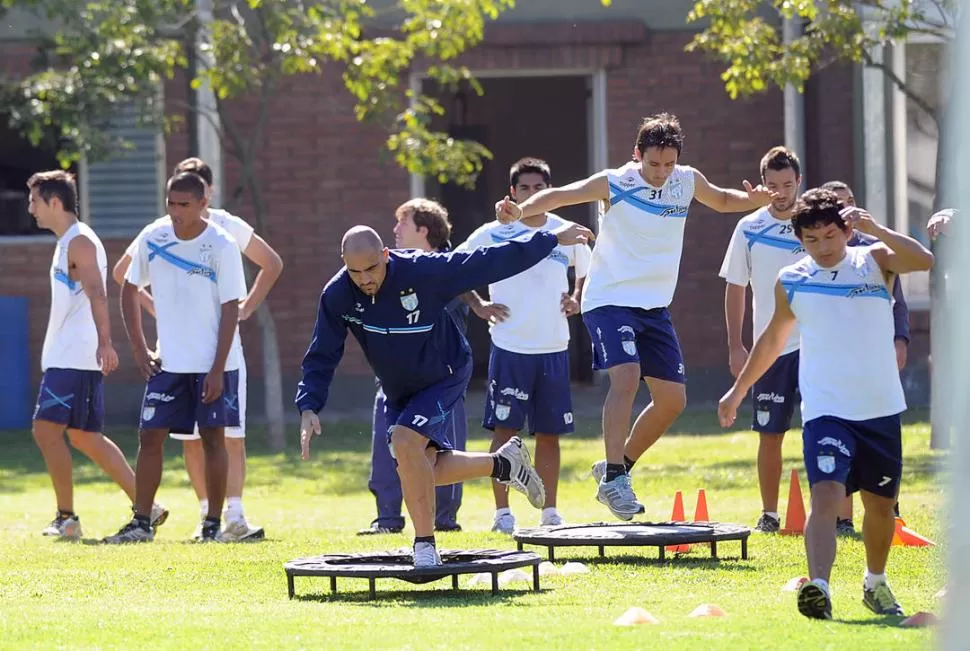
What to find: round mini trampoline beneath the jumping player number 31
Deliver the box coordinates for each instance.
[512,522,751,561]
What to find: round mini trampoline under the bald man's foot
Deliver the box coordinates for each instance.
[283,549,542,599]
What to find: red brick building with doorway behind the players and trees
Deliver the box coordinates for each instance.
[0,0,925,428]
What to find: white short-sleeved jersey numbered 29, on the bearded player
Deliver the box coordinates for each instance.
[720,208,805,354]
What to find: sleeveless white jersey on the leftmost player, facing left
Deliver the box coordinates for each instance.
[40,221,108,371]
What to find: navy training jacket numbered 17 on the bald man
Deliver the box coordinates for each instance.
[295,231,558,412]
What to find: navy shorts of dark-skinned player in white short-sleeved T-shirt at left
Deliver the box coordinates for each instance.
[139,371,239,434]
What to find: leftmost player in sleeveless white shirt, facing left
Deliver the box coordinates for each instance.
[27,170,168,540]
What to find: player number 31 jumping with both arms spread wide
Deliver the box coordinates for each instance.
[496,113,775,520]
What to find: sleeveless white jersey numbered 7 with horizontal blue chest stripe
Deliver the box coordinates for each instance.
[779,247,906,422]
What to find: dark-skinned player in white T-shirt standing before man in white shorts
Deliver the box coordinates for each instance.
[105,172,246,544]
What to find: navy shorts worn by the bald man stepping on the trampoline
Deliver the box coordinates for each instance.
[384,361,472,456]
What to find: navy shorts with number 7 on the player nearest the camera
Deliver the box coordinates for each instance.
[802,414,903,497]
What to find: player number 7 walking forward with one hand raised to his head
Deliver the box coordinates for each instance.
[718,189,933,619]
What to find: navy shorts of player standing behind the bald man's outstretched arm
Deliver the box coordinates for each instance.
[482,344,574,434]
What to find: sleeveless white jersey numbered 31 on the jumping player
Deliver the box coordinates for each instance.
[583,162,694,312]
